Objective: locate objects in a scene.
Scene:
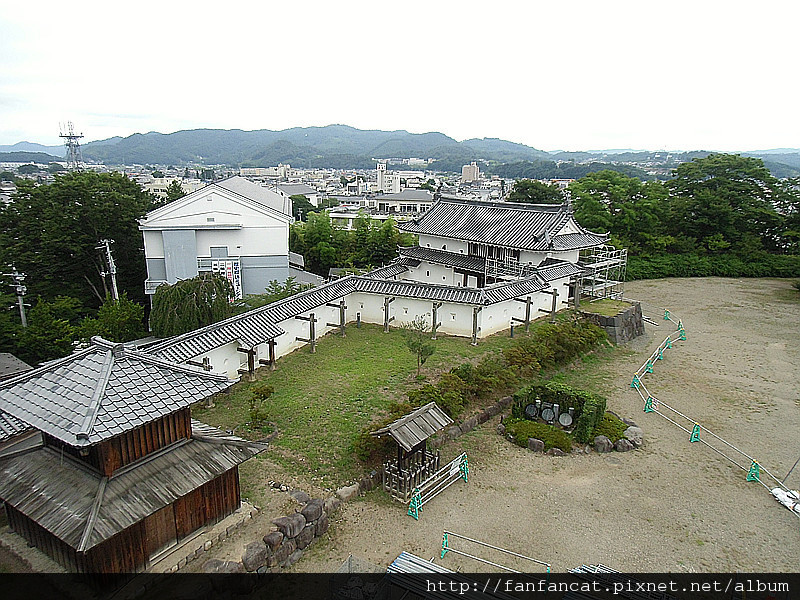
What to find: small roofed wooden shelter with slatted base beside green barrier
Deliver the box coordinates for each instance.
[370,402,453,502]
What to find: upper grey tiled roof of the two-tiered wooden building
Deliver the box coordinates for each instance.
[0,337,233,447]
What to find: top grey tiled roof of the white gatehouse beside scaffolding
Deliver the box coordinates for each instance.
[398,197,608,251]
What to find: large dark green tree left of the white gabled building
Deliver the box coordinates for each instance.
[0,172,151,307]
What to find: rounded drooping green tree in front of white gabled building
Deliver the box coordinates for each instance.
[150,273,234,337]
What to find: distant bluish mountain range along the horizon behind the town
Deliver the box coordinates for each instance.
[0,125,800,177]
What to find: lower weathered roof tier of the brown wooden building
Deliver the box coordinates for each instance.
[0,421,267,551]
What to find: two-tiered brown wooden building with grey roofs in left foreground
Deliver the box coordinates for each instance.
[0,338,266,573]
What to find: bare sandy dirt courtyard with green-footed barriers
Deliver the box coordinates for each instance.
[286,278,800,572]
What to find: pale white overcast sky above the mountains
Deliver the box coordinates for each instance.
[0,0,800,151]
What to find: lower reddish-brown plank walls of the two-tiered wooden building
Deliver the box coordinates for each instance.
[6,467,241,573]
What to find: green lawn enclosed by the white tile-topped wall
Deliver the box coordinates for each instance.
[193,324,512,487]
